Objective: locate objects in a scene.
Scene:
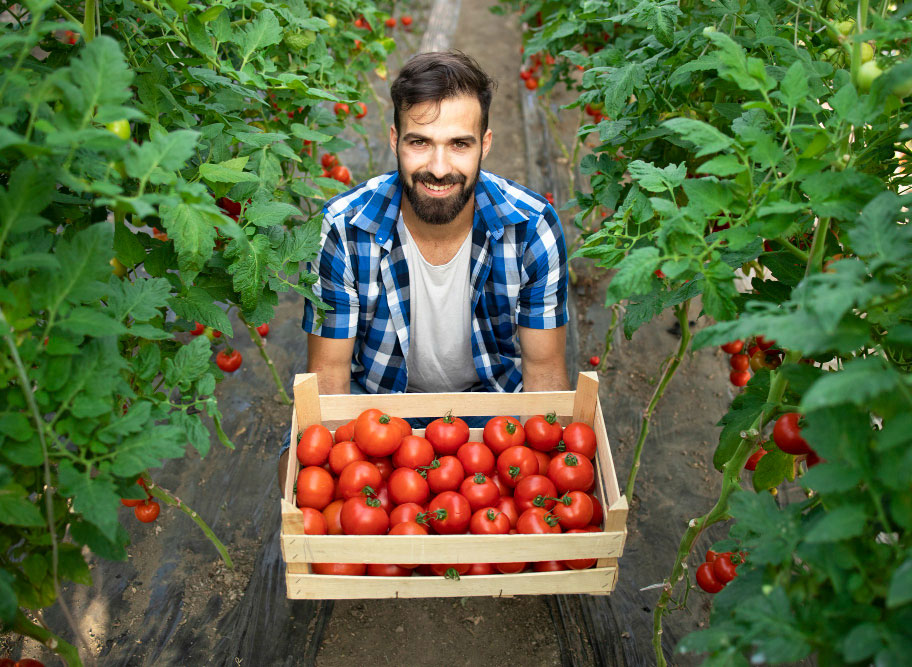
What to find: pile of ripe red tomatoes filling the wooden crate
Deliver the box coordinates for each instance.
[295,409,603,576]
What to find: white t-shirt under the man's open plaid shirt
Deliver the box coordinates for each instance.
[399,218,479,392]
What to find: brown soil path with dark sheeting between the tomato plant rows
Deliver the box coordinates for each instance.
[7,0,733,667]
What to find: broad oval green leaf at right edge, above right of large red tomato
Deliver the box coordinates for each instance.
[801,357,901,412]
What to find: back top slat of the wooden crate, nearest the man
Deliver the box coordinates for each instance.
[314,391,575,424]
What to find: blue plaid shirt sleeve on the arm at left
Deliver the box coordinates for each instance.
[301,215,359,338]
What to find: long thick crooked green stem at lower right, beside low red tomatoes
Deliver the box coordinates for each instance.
[652,351,801,667]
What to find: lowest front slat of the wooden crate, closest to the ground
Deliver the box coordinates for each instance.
[285,567,617,600]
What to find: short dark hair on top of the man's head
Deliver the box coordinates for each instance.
[390,50,497,135]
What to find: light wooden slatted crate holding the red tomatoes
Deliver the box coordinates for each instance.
[280,372,627,599]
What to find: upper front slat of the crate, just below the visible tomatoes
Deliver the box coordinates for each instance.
[281,531,626,563]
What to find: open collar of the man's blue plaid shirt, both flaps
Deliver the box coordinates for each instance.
[351,169,529,251]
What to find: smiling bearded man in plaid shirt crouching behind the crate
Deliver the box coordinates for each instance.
[283,52,569,480]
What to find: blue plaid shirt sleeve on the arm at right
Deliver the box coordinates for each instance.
[516,205,569,329]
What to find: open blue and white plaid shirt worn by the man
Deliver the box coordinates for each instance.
[302,170,568,393]
